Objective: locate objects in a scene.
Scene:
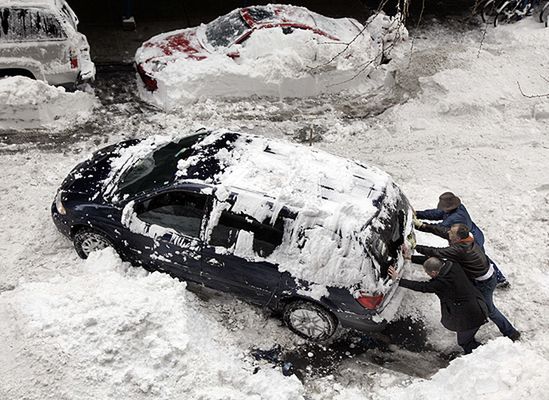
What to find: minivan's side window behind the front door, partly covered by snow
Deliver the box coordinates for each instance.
[209,211,284,257]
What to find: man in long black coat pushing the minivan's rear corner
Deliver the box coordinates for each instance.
[389,257,488,354]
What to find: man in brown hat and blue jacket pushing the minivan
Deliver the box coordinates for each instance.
[416,192,509,288]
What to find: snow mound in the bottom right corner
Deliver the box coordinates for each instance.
[379,338,549,400]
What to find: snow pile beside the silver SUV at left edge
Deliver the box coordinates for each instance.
[0,76,98,130]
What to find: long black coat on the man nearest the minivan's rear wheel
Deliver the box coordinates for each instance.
[400,261,488,332]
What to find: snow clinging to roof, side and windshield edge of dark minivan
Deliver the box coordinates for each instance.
[111,130,401,297]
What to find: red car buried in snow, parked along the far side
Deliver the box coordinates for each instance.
[135,4,407,108]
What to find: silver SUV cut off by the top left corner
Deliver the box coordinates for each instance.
[0,0,95,89]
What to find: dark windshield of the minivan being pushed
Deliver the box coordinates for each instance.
[117,134,204,198]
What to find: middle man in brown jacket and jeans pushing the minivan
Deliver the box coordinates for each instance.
[415,224,520,341]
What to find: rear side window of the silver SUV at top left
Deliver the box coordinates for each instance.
[0,8,67,42]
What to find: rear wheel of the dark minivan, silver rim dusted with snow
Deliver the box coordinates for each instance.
[283,300,337,342]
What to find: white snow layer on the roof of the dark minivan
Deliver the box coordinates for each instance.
[178,130,390,219]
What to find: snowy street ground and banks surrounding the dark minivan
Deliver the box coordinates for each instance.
[0,19,549,400]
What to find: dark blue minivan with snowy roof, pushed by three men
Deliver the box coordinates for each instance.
[52,130,414,340]
